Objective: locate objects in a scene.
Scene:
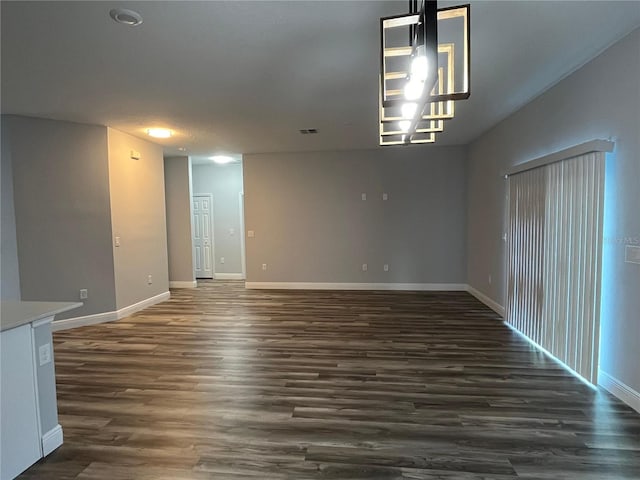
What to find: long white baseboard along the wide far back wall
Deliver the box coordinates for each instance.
[245,282,467,292]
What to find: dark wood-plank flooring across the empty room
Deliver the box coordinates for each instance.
[20,282,640,480]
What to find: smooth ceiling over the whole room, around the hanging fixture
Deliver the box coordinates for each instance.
[1,0,640,155]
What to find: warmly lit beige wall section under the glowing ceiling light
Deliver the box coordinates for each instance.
[108,128,169,309]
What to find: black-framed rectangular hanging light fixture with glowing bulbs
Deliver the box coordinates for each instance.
[379,0,471,145]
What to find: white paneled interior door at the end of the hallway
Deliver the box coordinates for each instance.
[193,194,213,278]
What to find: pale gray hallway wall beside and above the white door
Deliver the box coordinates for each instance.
[193,163,242,274]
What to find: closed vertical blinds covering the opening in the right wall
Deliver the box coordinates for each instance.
[506,152,605,384]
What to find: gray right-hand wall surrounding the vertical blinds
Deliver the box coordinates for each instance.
[468,30,640,391]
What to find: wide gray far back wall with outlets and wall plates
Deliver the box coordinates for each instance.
[244,146,467,283]
